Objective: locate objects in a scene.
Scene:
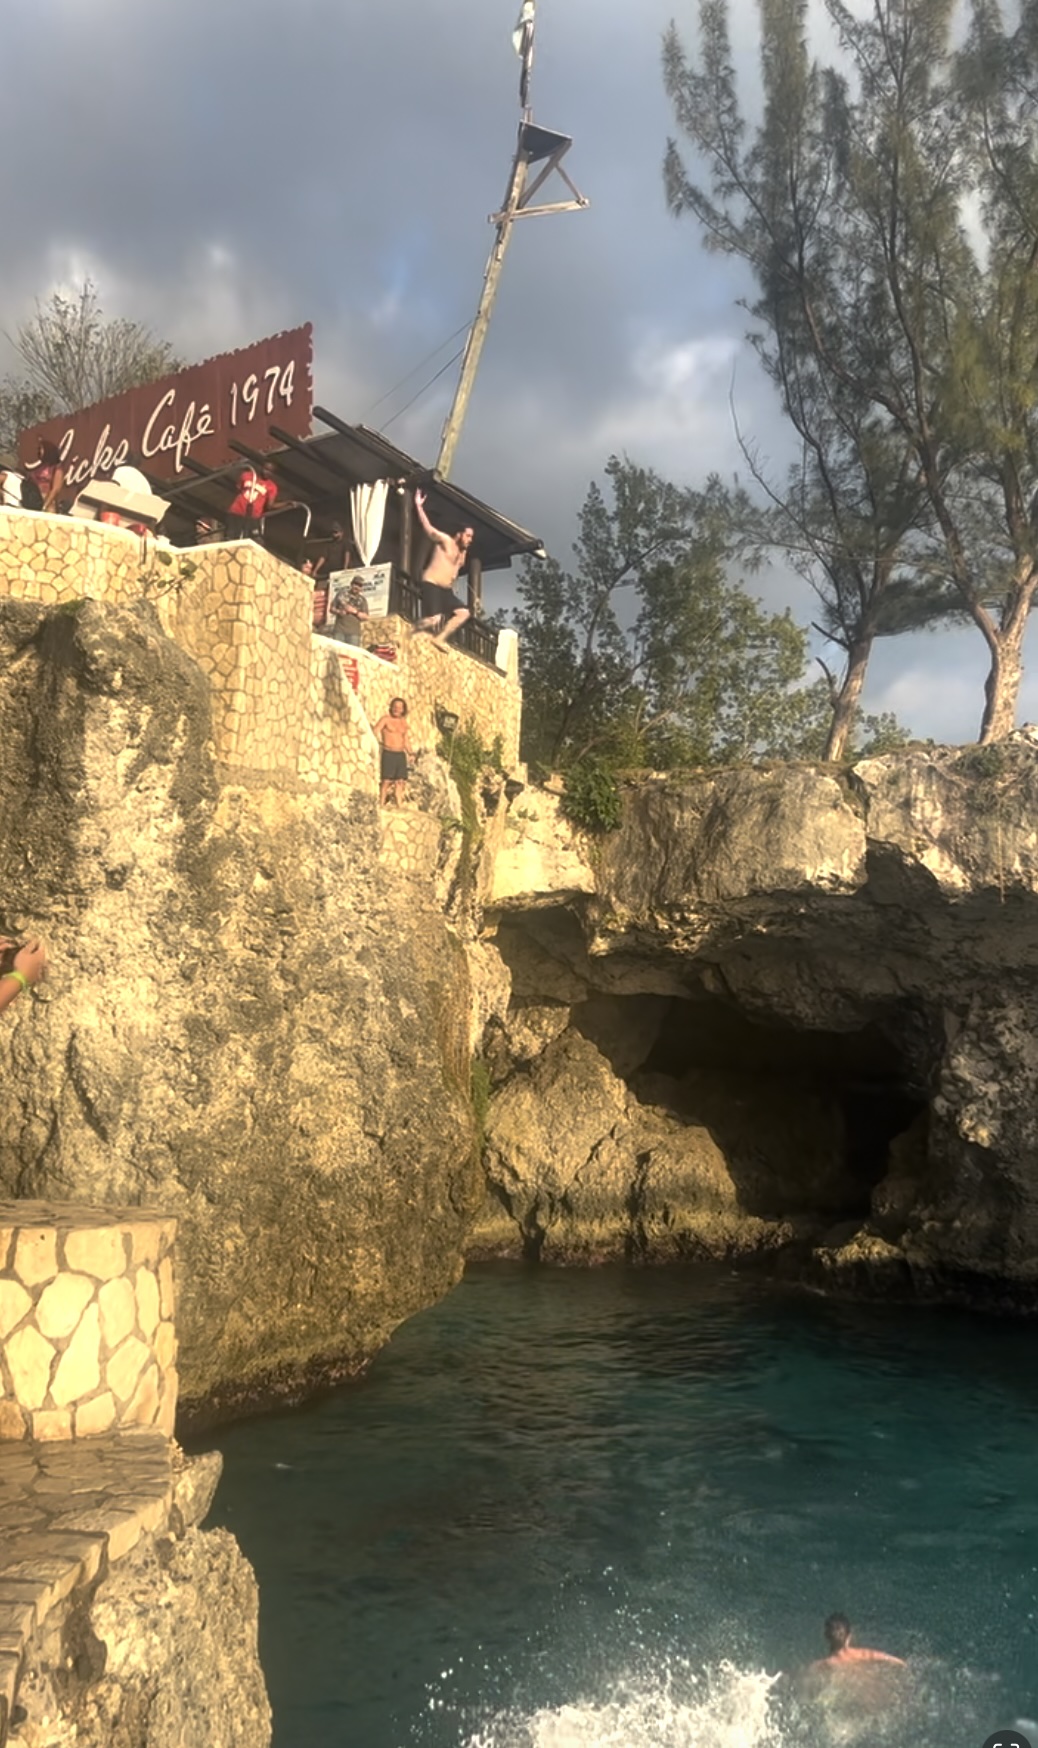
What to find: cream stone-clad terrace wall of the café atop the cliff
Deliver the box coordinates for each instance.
[0,510,522,794]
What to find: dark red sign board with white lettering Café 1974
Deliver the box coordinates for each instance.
[17,322,313,489]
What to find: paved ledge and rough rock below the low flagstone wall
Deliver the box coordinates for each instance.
[0,1428,271,1748]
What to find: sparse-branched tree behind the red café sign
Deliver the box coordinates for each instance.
[0,280,182,447]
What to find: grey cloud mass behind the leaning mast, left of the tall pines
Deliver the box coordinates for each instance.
[0,0,751,492]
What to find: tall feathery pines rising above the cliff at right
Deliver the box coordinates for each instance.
[664,0,1038,739]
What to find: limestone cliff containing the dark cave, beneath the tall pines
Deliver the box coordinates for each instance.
[474,731,1038,1308]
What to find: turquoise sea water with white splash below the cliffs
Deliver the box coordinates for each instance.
[206,1267,1038,1748]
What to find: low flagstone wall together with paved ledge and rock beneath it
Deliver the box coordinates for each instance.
[0,1201,271,1748]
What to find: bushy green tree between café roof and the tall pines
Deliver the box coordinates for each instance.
[517,456,849,769]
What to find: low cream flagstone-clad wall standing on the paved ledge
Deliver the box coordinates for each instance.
[0,1201,176,1440]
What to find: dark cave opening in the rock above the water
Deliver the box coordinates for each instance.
[570,995,926,1222]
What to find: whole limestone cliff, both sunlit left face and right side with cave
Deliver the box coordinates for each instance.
[0,587,1038,1433]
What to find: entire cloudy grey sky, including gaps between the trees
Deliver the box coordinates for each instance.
[0,0,1020,741]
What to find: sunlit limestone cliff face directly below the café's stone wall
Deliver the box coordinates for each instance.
[0,601,481,1409]
